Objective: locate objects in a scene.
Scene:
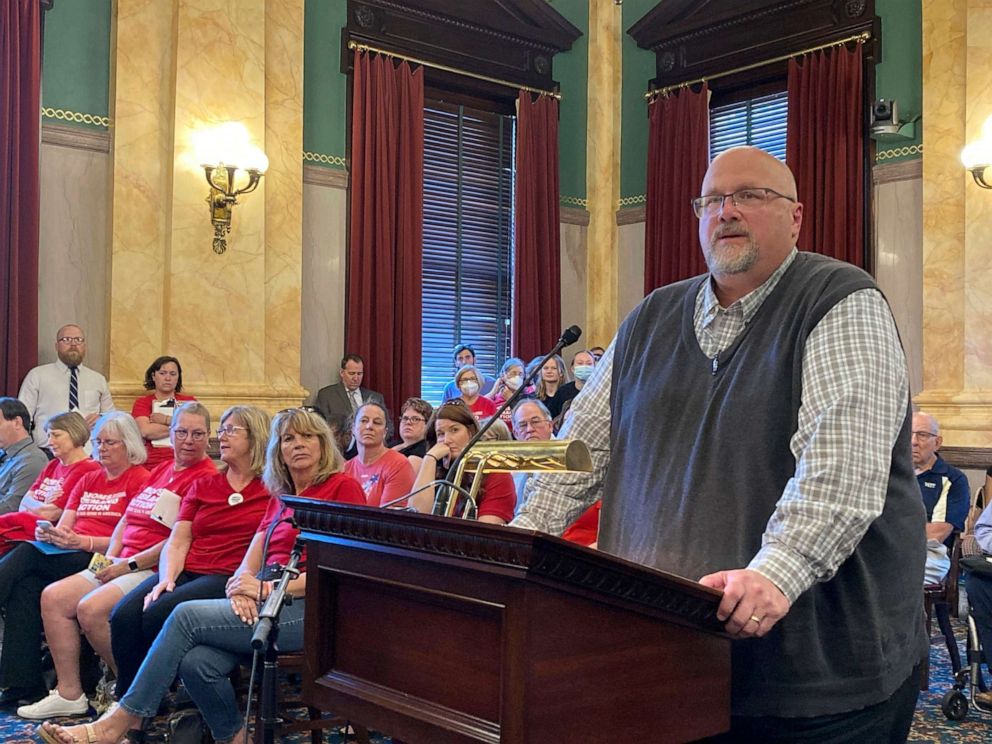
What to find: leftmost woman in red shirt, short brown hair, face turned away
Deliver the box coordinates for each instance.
[0,411,100,556]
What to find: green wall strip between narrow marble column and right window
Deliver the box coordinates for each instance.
[620,0,658,202]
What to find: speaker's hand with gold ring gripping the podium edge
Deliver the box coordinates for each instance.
[699,568,789,638]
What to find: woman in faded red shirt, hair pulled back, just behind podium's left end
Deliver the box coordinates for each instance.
[344,403,413,506]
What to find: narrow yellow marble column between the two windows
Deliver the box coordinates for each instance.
[585,0,622,344]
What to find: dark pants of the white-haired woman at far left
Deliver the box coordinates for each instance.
[0,543,93,689]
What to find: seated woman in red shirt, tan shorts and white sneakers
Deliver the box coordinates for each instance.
[17,402,217,720]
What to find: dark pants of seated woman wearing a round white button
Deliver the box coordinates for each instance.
[110,571,230,699]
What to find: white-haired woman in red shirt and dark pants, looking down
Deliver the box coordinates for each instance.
[0,411,148,708]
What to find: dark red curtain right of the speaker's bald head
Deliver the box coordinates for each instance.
[786,44,865,267]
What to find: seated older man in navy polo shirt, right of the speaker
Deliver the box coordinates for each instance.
[913,411,971,584]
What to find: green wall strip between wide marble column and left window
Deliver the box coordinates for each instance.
[303,0,348,168]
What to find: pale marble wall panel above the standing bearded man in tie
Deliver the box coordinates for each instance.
[38,143,110,373]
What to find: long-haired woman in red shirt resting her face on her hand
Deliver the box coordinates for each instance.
[410,399,517,524]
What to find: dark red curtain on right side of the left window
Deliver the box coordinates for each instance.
[512,91,561,360]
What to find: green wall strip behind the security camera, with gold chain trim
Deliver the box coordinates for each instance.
[875,0,923,163]
